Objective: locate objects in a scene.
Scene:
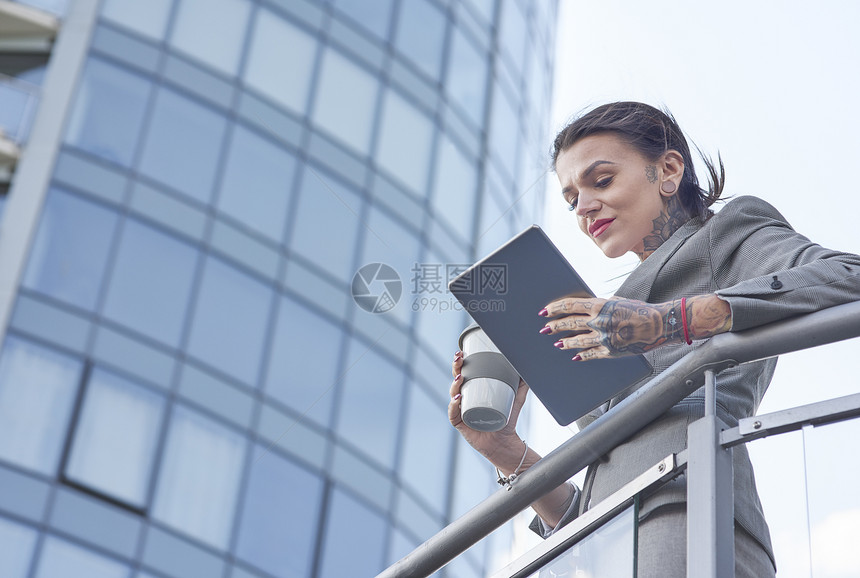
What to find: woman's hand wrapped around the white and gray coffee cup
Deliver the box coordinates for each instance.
[448,351,529,470]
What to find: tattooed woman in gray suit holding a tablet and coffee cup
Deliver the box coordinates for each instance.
[448,102,860,578]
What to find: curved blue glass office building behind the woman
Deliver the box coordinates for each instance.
[0,0,556,578]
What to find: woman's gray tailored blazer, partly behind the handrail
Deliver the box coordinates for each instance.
[535,197,860,558]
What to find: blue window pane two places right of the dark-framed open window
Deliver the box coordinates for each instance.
[236,447,323,578]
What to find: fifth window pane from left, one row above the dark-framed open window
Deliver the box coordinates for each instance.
[337,340,404,468]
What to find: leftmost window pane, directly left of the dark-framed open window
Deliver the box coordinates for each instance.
[0,336,82,475]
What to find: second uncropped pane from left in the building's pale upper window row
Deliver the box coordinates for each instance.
[312,49,377,154]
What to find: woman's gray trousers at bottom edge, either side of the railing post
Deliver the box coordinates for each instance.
[637,504,776,578]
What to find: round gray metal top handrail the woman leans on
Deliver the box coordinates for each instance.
[377,301,860,578]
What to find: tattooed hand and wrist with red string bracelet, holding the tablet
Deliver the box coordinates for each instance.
[541,295,731,361]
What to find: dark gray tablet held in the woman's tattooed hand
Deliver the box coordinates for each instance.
[448,225,651,426]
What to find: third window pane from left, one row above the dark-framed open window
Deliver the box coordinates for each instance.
[188,258,271,386]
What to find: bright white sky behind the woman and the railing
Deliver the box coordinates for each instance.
[530,0,860,578]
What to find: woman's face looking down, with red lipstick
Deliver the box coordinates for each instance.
[556,133,665,259]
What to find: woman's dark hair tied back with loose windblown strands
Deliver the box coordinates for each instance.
[552,102,726,217]
